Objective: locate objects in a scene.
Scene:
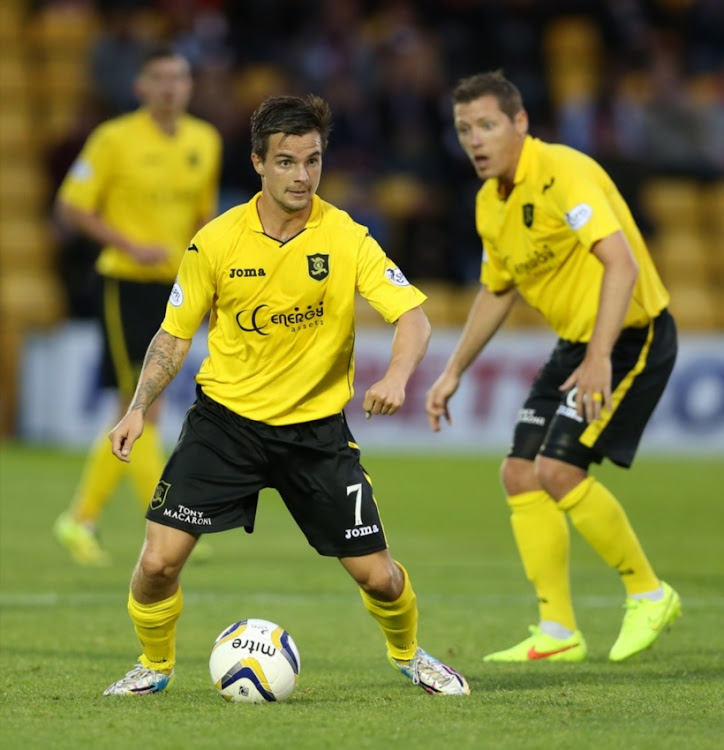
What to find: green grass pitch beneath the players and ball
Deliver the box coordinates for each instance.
[0,444,724,750]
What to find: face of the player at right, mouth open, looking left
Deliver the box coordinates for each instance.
[453,95,528,184]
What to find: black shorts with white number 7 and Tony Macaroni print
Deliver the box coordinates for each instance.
[146,387,387,557]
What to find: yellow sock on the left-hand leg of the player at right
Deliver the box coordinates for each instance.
[508,490,577,631]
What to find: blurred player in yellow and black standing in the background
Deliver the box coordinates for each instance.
[54,47,221,565]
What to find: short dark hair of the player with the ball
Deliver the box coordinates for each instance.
[251,94,332,161]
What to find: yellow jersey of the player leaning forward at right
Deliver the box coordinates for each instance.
[475,136,669,342]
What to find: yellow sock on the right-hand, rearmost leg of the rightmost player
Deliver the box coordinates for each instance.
[558,476,661,596]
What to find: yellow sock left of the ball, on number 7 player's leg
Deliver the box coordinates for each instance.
[128,586,183,672]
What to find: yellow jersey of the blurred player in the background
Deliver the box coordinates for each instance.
[59,108,221,283]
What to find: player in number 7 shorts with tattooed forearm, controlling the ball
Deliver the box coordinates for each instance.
[100,96,469,695]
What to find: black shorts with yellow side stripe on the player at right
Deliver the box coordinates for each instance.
[508,310,677,469]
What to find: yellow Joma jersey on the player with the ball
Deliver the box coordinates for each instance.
[162,194,426,425]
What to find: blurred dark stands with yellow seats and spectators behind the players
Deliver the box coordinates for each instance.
[0,0,724,434]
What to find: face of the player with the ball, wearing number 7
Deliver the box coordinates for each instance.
[251,130,322,213]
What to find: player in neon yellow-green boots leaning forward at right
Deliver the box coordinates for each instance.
[426,71,681,662]
